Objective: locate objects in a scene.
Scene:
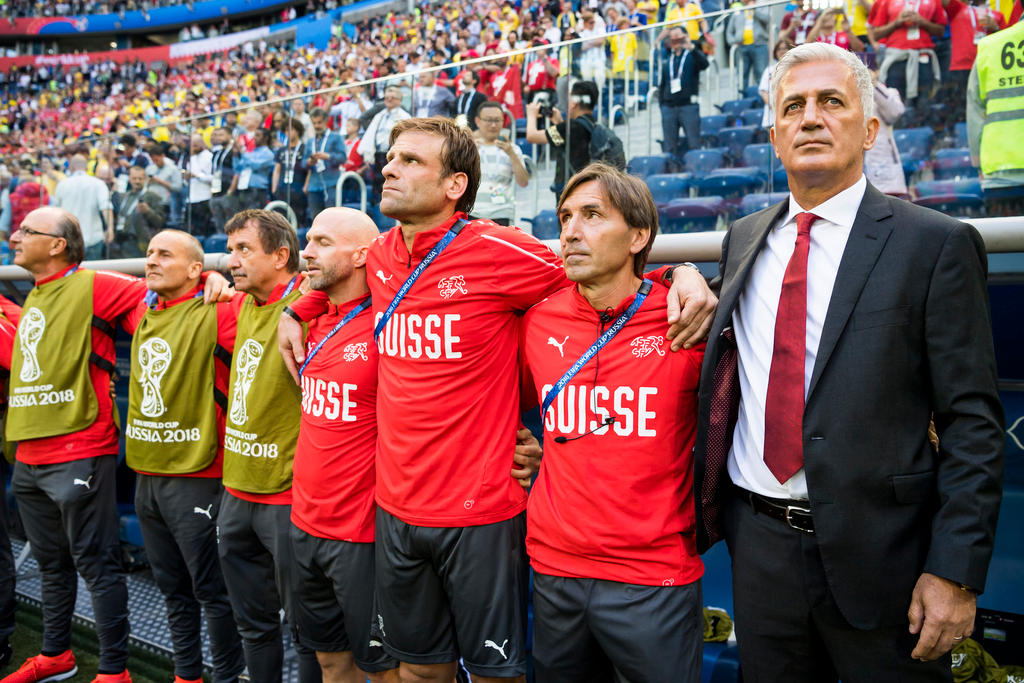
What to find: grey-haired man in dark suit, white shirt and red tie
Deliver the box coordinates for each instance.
[694,43,1004,683]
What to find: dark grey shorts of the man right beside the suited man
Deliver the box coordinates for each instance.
[534,572,703,683]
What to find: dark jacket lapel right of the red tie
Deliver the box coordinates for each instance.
[807,183,893,400]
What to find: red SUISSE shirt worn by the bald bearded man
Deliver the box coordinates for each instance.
[292,296,378,543]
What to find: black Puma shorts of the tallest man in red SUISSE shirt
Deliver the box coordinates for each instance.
[375,509,528,678]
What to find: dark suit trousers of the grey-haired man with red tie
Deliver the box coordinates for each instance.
[724,496,952,683]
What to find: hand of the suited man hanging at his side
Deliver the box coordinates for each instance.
[907,573,978,661]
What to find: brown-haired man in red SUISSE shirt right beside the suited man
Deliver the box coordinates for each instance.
[520,164,705,683]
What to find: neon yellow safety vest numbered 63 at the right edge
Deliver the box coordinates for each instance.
[976,22,1024,175]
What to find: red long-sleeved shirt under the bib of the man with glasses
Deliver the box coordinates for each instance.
[17,265,146,465]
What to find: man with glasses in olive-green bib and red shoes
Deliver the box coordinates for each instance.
[4,207,226,683]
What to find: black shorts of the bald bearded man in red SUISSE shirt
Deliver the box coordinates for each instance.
[292,524,398,674]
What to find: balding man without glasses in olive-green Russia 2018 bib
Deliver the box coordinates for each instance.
[124,228,245,683]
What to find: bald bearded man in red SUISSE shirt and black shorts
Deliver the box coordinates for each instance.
[292,208,397,683]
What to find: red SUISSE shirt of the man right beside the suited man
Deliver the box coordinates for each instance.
[522,284,703,586]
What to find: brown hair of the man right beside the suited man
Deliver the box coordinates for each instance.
[556,162,657,278]
